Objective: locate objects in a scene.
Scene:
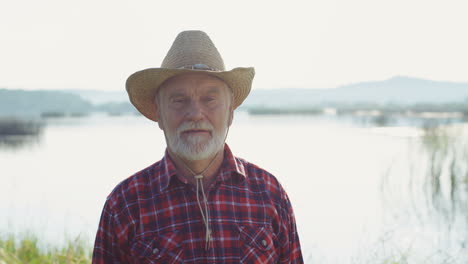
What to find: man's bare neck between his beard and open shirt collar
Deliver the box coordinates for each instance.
[168,148,224,189]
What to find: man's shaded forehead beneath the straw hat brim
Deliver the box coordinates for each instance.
[156,73,232,98]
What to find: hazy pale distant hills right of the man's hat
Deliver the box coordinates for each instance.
[243,76,468,108]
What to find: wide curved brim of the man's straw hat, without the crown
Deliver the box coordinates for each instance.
[125,67,255,122]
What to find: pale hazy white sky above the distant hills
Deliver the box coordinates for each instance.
[0,0,468,90]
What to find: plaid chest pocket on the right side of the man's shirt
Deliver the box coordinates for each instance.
[239,225,278,264]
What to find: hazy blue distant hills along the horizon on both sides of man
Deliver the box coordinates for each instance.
[0,76,468,115]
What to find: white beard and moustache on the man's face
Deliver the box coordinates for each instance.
[166,122,227,161]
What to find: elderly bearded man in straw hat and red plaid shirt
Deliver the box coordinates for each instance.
[93,31,303,263]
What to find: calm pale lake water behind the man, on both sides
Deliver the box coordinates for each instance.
[0,112,465,263]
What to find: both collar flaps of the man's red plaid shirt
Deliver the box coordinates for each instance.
[159,144,246,191]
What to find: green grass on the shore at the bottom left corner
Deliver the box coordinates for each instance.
[0,235,92,264]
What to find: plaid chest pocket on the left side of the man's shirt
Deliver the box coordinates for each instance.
[130,231,184,264]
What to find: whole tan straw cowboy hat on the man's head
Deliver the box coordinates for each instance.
[126,31,255,122]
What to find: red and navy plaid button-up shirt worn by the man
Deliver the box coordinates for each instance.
[93,145,303,264]
